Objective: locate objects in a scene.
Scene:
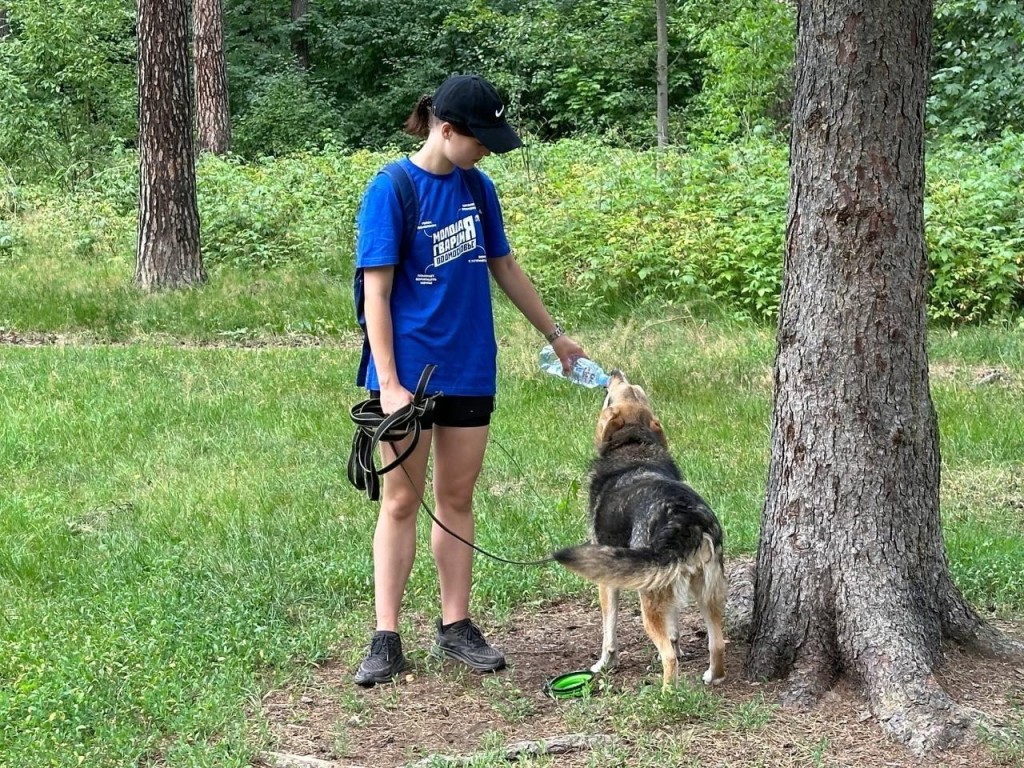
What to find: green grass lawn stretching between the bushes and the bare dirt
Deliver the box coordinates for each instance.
[0,299,1024,768]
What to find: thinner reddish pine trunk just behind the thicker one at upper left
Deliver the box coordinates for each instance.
[193,0,231,155]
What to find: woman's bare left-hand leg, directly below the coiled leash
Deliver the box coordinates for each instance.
[374,430,432,632]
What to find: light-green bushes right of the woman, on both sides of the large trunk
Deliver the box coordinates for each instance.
[493,135,1024,324]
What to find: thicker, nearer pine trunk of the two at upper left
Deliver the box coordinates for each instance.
[135,0,206,291]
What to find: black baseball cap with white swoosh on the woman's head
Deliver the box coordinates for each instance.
[432,75,522,155]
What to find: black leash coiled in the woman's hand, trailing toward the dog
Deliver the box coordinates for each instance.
[348,362,555,565]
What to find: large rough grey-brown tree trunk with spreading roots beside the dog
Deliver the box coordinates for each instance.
[746,0,1020,752]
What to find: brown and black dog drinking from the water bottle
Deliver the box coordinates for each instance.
[554,371,727,688]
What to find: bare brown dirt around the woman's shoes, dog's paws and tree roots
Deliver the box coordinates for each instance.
[251,599,1024,768]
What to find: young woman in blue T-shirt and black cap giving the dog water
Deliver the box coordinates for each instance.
[355,75,585,686]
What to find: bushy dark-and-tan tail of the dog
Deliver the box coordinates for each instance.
[552,534,721,592]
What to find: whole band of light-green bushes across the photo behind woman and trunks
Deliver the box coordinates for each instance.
[8,135,1024,325]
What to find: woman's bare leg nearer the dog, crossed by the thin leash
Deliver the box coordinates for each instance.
[430,425,488,625]
